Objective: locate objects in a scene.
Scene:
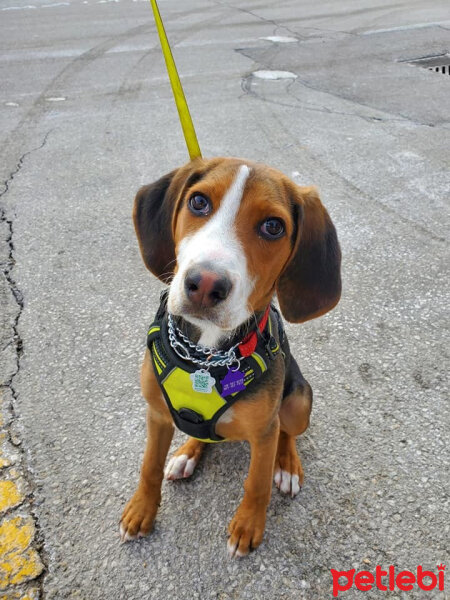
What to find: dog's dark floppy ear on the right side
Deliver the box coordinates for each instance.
[277,182,341,323]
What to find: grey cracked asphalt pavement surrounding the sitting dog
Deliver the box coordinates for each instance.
[0,0,450,600]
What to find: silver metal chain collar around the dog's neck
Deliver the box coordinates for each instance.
[167,313,240,369]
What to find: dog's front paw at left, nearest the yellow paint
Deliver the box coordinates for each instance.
[119,489,158,542]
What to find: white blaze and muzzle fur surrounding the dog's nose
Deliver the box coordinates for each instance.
[168,165,253,343]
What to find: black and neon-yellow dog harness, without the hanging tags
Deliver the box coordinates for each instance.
[147,298,281,442]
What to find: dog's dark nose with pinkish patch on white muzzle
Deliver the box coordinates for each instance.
[184,266,232,308]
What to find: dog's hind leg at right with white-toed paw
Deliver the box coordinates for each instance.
[274,358,312,498]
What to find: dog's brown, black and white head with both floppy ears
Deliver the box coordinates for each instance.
[133,158,341,332]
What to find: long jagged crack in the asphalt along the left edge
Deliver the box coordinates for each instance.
[0,129,53,599]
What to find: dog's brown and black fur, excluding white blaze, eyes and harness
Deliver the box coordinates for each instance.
[121,159,341,556]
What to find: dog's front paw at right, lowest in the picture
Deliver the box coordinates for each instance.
[227,504,266,558]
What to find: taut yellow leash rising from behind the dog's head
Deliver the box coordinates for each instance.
[150,0,202,160]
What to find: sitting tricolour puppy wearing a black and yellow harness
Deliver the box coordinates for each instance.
[120,158,341,557]
